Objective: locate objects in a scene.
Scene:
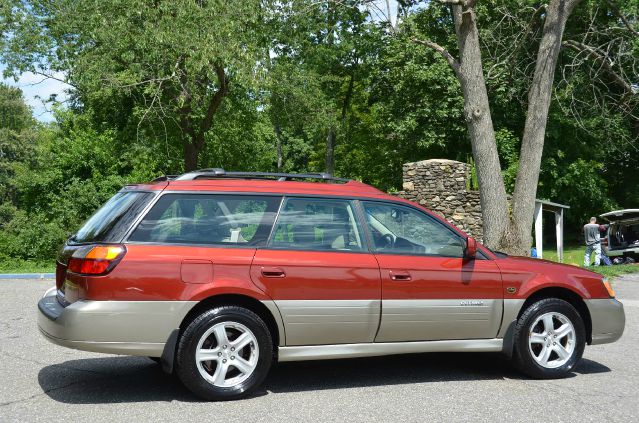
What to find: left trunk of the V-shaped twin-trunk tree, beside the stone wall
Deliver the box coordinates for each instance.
[453,5,509,248]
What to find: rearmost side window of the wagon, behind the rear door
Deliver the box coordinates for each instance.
[128,194,281,246]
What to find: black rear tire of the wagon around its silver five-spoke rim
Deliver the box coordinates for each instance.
[176,306,273,401]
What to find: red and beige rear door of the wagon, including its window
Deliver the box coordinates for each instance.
[251,197,381,345]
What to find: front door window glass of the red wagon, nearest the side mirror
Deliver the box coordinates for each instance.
[363,202,464,257]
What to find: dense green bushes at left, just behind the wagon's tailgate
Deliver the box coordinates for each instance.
[0,99,159,261]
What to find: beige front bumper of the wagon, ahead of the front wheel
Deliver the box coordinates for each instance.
[586,298,626,345]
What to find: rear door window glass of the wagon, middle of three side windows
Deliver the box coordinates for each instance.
[271,198,362,251]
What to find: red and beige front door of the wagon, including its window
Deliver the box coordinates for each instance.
[362,202,503,342]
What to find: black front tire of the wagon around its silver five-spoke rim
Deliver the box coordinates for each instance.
[513,298,586,379]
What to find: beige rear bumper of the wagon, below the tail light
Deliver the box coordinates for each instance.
[38,289,196,357]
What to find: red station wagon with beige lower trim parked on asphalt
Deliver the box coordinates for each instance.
[38,169,625,400]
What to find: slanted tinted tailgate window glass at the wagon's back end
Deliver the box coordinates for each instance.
[69,191,153,244]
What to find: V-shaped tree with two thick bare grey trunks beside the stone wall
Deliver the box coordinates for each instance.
[413,0,580,255]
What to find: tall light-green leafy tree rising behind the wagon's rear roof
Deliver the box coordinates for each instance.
[0,0,264,170]
